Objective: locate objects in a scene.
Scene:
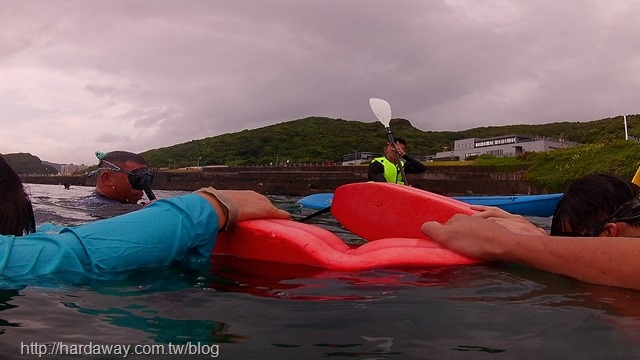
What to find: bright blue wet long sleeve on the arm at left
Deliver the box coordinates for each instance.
[0,194,218,279]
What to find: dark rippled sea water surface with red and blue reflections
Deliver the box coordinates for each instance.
[0,184,640,360]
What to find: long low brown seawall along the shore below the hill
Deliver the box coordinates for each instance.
[22,165,547,196]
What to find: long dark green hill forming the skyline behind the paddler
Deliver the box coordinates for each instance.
[141,115,640,168]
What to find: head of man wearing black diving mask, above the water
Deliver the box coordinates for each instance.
[96,151,153,204]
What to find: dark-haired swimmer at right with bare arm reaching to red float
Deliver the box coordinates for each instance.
[422,174,640,289]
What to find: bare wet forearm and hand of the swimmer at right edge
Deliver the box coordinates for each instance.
[422,215,640,289]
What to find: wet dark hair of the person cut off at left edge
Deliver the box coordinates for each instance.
[0,155,36,236]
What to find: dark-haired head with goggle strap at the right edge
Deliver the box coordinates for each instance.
[551,174,640,236]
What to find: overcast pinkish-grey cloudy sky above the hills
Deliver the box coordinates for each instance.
[0,0,640,165]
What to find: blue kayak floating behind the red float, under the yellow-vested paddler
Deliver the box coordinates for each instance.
[298,193,562,217]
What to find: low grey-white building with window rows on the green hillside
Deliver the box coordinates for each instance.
[433,134,579,161]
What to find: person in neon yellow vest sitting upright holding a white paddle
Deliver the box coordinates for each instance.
[367,138,427,184]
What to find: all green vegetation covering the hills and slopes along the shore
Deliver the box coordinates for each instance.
[5,115,640,192]
